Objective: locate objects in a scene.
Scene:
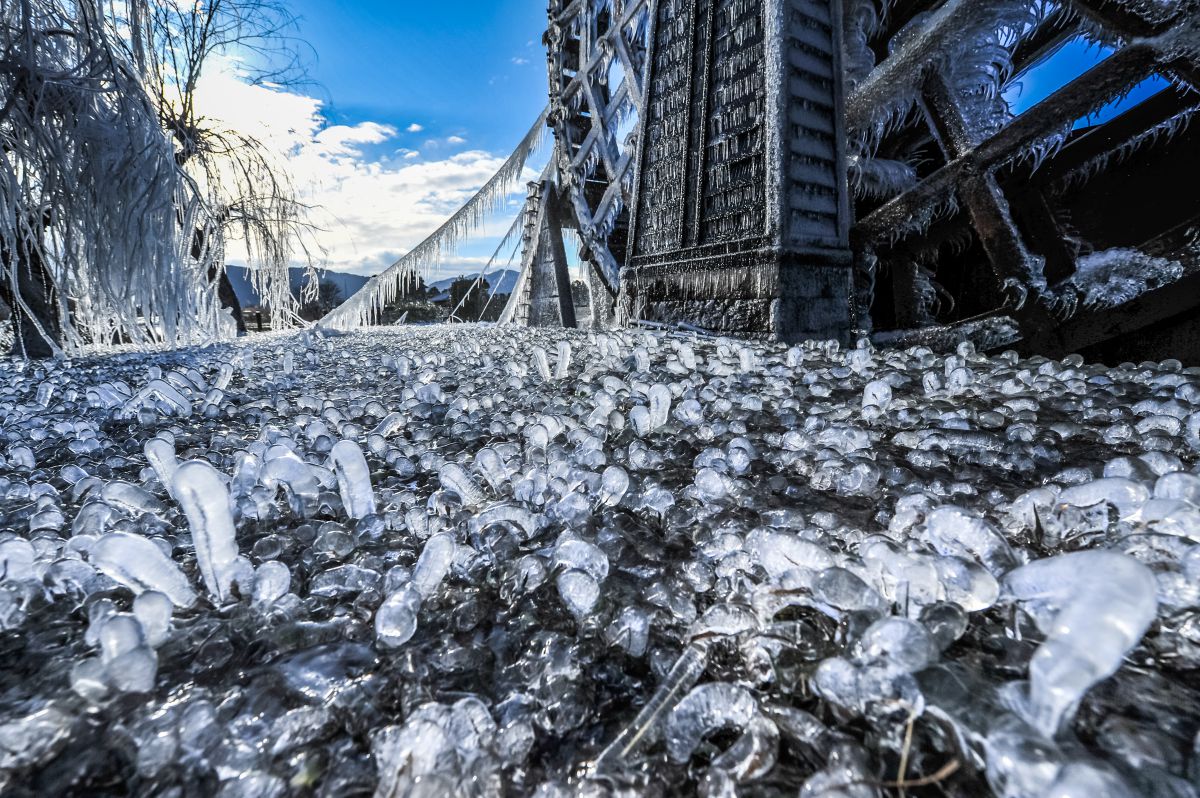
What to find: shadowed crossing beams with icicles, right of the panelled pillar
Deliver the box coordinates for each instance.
[846,0,1200,349]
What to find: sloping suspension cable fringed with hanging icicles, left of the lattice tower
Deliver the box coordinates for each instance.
[318,108,550,330]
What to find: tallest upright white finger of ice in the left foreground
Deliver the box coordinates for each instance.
[174,460,238,602]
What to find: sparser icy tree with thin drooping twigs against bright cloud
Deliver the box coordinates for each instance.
[127,0,317,326]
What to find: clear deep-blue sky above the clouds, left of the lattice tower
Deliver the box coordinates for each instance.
[290,0,546,157]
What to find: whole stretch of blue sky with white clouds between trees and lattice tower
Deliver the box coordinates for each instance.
[207,0,550,278]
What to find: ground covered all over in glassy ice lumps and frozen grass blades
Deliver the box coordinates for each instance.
[0,325,1200,798]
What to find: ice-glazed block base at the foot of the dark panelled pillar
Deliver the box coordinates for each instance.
[620,251,856,343]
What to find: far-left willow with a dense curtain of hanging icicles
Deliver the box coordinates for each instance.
[0,0,201,356]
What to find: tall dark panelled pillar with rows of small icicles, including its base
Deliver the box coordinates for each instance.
[620,0,854,341]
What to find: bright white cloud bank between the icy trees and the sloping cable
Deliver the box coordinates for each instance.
[198,59,533,275]
